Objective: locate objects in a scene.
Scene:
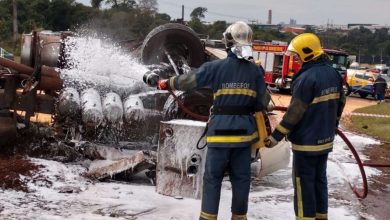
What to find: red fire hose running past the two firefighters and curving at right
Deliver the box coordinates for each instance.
[169,96,390,199]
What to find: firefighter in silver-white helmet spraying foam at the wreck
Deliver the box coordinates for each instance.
[158,22,270,220]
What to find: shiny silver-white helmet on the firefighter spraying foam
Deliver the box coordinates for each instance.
[223,21,253,48]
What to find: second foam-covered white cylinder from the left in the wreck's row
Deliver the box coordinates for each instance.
[81,88,103,127]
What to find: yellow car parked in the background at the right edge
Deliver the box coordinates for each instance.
[346,70,390,98]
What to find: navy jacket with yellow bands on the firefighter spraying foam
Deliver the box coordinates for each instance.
[167,51,270,147]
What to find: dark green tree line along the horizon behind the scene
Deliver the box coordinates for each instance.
[0,0,390,63]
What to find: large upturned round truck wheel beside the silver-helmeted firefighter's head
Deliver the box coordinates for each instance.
[141,23,205,68]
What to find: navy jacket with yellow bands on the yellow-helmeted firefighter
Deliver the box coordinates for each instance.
[272,58,345,155]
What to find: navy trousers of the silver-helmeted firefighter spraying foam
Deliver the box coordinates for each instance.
[201,145,251,219]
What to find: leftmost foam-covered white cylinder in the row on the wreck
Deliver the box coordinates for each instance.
[58,88,80,116]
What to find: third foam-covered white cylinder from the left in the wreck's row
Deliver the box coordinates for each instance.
[103,92,123,123]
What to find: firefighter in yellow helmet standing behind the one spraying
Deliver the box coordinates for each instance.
[266,33,345,220]
